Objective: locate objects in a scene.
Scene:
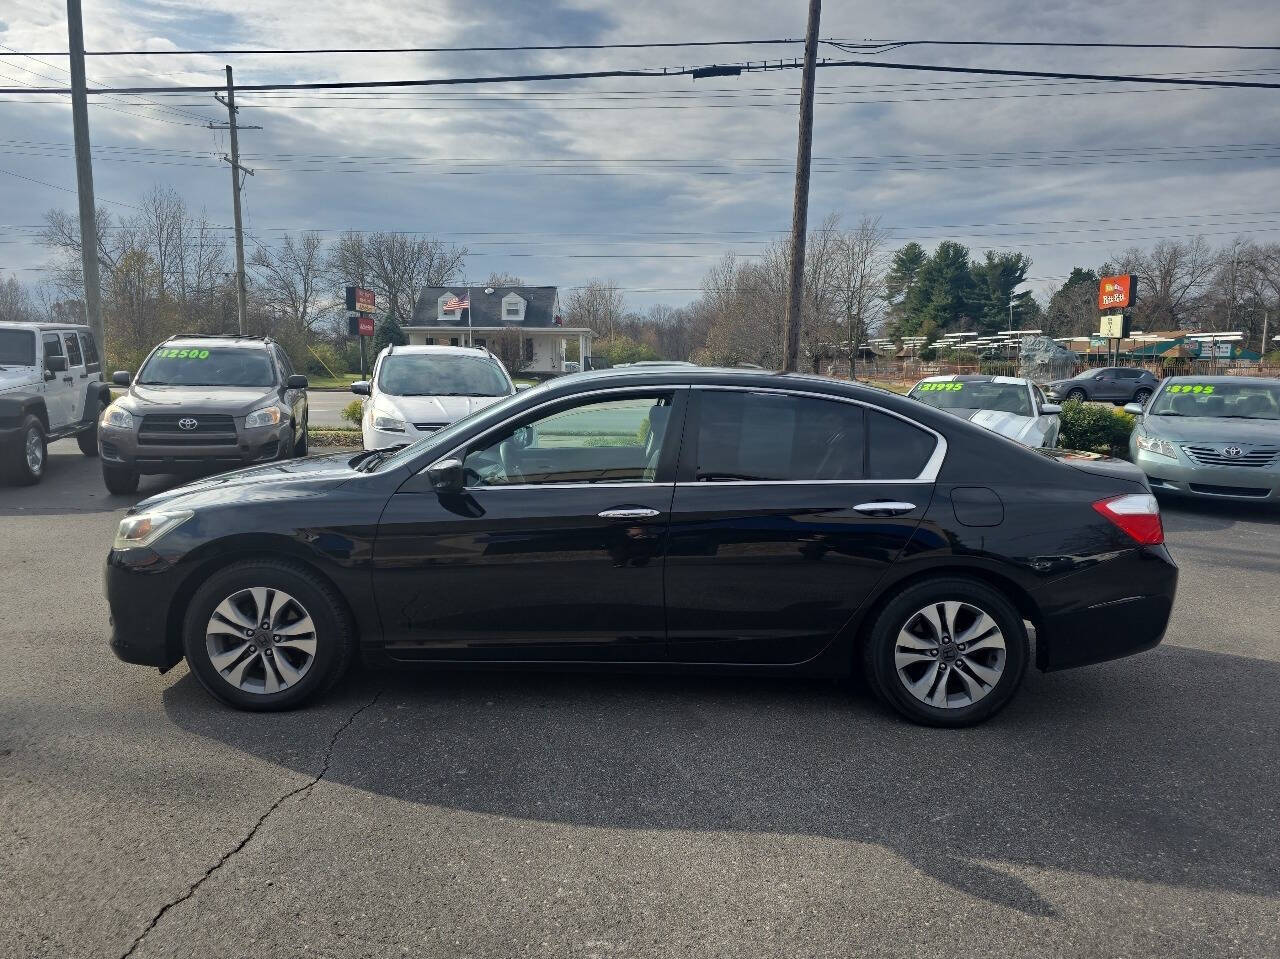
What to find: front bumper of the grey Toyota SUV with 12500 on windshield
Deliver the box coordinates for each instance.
[97,420,293,474]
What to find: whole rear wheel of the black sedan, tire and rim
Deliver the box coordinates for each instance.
[863,577,1029,726]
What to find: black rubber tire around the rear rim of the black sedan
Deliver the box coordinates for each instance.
[863,576,1030,727]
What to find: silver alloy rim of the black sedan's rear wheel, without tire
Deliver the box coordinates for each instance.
[893,600,1007,709]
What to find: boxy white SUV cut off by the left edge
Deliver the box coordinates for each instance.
[0,323,111,485]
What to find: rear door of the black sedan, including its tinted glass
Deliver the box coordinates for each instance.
[666,388,946,663]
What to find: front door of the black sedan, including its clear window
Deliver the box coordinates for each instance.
[372,388,687,661]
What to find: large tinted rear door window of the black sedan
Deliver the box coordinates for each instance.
[694,389,867,483]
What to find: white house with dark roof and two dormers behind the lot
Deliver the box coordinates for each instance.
[404,286,593,376]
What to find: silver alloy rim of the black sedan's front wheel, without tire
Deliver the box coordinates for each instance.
[205,586,316,695]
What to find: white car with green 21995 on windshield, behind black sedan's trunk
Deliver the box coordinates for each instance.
[908,375,1062,449]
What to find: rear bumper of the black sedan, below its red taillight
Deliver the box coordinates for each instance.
[1032,545,1178,671]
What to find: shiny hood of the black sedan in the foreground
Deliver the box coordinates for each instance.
[131,452,357,512]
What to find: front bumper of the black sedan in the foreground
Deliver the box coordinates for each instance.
[104,548,183,670]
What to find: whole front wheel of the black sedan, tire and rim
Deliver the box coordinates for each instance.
[183,560,355,711]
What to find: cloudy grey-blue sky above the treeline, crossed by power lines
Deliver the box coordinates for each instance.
[0,0,1280,306]
